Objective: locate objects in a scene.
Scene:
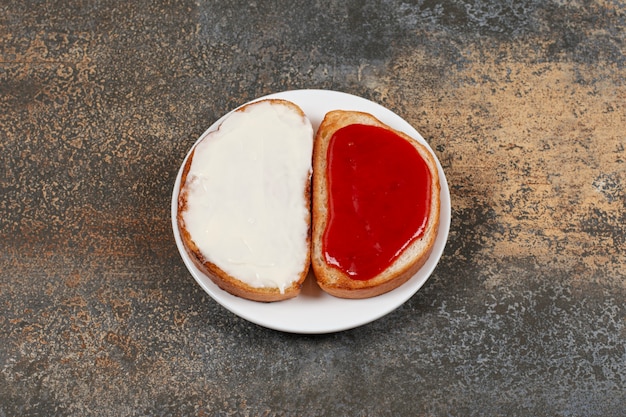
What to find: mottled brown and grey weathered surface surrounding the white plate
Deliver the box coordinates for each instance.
[0,0,626,416]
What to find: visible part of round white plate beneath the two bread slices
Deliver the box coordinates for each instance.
[172,90,450,334]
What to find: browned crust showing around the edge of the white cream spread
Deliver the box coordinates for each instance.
[177,99,311,302]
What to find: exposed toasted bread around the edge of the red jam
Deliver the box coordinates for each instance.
[311,110,440,299]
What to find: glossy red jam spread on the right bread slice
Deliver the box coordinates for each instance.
[322,124,431,280]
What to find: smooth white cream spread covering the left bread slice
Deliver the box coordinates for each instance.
[183,102,313,292]
